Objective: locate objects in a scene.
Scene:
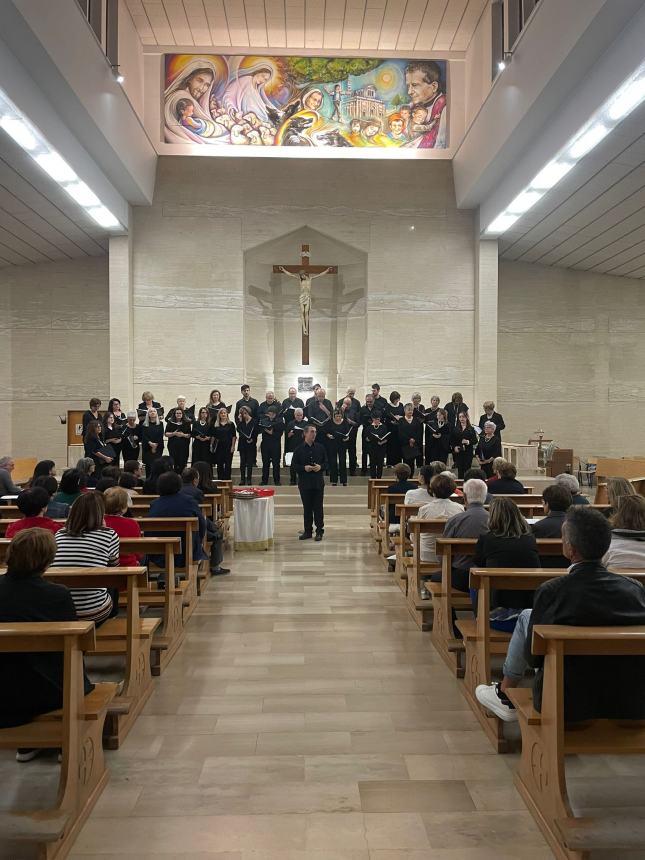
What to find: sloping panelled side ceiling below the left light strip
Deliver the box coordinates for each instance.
[0,131,108,267]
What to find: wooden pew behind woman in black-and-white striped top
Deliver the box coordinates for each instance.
[44,567,161,749]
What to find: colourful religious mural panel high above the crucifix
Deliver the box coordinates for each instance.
[163,54,448,149]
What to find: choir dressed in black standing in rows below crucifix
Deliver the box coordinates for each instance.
[83,383,505,486]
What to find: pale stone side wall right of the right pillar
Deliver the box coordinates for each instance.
[498,262,645,457]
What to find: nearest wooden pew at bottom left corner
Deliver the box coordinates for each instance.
[0,621,116,860]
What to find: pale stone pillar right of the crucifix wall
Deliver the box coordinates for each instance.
[470,233,504,412]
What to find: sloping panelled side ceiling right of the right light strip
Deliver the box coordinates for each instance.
[500,101,645,278]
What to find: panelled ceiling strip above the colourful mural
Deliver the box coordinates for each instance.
[126,0,488,54]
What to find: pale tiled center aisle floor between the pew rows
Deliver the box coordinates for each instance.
[70,485,552,860]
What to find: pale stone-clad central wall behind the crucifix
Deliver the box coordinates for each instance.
[134,157,475,406]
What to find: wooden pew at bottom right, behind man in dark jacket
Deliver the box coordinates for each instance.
[508,625,645,860]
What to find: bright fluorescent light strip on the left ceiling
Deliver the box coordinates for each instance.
[0,90,123,230]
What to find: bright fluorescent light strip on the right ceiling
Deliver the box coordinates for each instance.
[485,63,645,236]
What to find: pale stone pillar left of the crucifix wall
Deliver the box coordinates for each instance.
[109,234,138,409]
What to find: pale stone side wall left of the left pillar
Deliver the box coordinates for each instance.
[0,257,110,466]
